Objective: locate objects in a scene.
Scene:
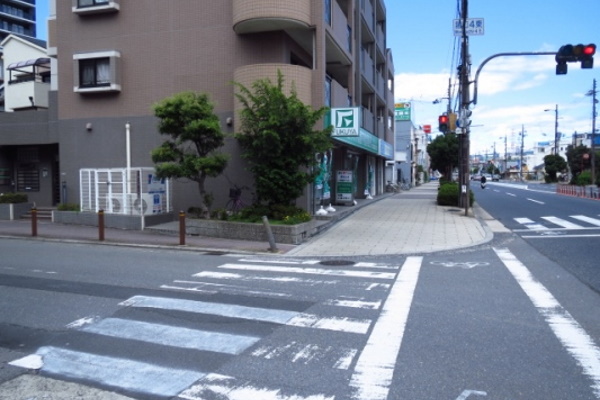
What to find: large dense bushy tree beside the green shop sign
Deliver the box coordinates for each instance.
[235,71,332,206]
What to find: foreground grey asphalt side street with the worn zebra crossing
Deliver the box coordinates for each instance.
[0,233,600,400]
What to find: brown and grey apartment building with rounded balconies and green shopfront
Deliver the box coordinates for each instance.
[0,0,394,219]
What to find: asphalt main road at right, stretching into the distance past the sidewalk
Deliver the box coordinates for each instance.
[473,183,600,293]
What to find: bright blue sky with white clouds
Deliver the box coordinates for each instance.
[37,0,600,154]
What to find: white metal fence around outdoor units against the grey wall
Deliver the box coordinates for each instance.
[79,167,173,215]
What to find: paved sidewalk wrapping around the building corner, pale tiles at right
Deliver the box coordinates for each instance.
[0,182,491,257]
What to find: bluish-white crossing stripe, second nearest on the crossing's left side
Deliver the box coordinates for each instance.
[81,318,260,354]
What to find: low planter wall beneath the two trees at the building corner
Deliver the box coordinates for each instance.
[186,219,319,244]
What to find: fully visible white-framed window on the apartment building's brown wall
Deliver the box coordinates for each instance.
[73,51,121,93]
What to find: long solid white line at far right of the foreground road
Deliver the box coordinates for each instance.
[494,248,600,398]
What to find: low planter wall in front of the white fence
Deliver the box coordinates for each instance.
[52,211,175,230]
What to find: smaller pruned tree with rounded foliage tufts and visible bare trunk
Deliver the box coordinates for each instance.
[152,92,227,218]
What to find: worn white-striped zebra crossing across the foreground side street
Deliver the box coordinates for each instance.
[13,258,400,400]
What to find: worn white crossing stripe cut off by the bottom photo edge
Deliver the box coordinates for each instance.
[178,374,335,400]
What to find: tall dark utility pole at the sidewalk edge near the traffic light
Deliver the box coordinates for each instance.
[459,0,471,216]
